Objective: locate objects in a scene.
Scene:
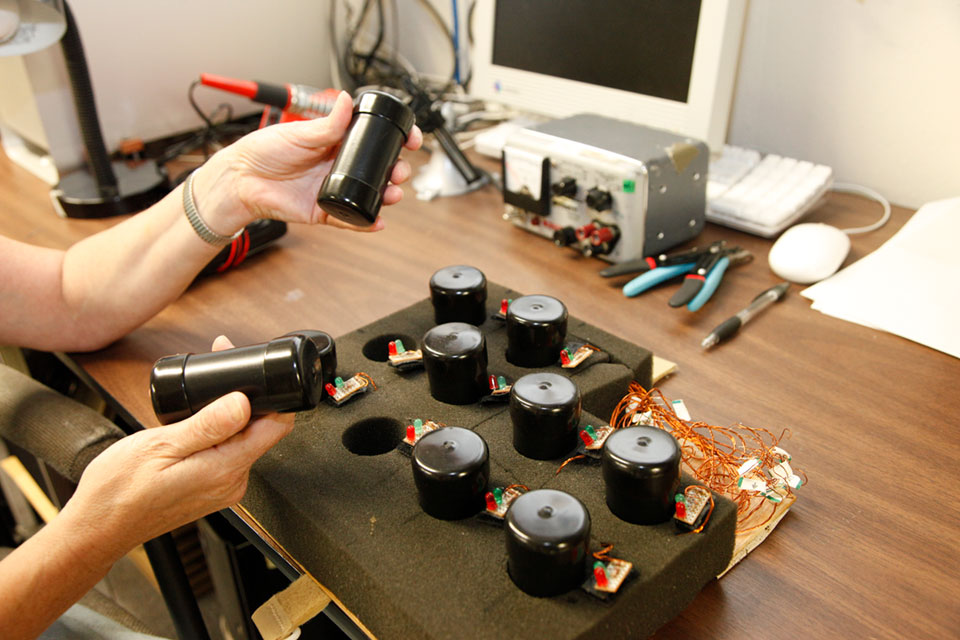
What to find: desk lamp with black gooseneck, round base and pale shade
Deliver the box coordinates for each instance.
[0,0,169,218]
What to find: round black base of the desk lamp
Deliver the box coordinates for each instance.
[50,160,170,218]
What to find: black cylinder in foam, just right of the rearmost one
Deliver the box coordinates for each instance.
[507,295,567,367]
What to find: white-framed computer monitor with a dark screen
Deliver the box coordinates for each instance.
[470,0,746,151]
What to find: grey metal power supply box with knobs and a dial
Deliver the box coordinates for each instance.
[502,114,710,263]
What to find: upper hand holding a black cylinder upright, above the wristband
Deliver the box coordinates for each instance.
[194,92,423,233]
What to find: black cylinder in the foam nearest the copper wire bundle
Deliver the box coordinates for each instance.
[601,427,680,524]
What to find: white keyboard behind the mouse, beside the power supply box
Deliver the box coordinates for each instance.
[707,145,833,238]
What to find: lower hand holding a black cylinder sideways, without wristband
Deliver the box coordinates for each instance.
[63,336,293,557]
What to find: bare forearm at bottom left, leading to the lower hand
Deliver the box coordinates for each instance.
[0,514,124,640]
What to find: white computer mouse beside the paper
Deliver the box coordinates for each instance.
[767,222,850,284]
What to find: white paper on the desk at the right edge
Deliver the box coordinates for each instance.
[800,198,960,358]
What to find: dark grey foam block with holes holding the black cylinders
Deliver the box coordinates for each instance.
[243,283,736,640]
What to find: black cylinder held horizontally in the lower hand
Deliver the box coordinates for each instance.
[150,334,323,424]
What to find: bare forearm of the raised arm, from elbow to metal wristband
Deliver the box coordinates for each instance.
[55,158,250,351]
